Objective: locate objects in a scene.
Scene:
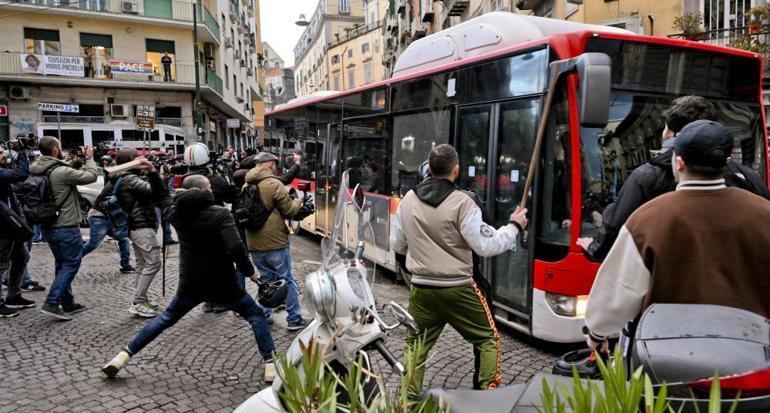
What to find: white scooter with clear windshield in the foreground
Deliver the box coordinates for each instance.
[235,172,418,413]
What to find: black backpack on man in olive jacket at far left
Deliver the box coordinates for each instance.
[17,164,74,226]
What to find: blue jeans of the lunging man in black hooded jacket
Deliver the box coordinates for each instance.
[126,294,275,360]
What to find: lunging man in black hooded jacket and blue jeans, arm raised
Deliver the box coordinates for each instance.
[102,173,275,381]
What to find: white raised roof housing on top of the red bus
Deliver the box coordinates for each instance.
[393,12,635,77]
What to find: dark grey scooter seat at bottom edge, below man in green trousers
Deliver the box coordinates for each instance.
[426,384,527,413]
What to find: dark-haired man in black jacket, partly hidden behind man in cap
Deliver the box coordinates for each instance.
[577,96,770,262]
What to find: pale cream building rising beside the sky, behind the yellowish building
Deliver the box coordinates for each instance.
[294,0,366,96]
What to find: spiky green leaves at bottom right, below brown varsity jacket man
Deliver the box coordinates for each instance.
[535,349,737,413]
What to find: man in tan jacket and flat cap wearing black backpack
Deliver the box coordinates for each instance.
[246,152,307,331]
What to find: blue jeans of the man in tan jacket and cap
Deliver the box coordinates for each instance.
[251,248,302,323]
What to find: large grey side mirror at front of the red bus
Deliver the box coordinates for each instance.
[576,52,612,128]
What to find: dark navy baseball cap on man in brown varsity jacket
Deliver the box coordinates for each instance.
[674,119,733,170]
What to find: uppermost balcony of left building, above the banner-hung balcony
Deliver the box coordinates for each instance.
[2,0,220,44]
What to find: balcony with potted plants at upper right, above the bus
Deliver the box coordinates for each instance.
[668,24,770,77]
